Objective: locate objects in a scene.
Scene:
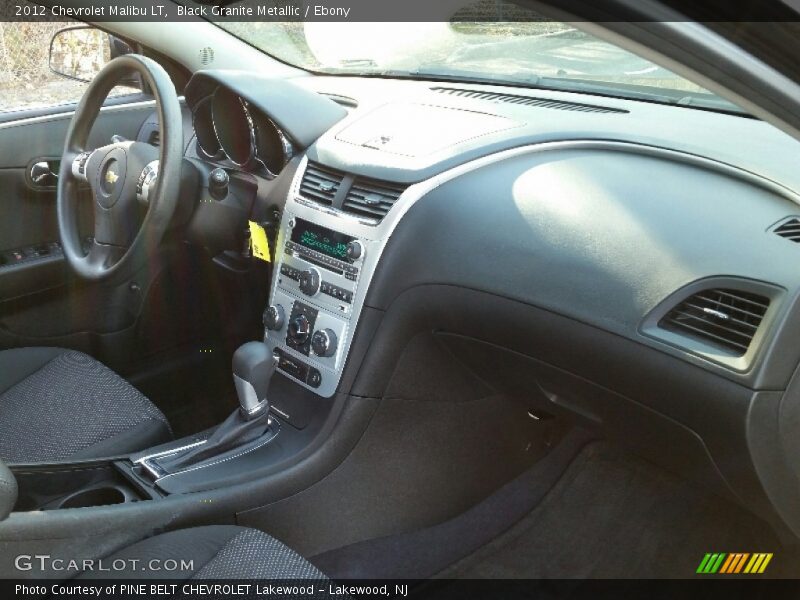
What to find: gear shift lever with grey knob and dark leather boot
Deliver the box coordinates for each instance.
[151,342,278,473]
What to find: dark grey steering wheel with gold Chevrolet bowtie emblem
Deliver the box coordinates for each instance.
[57,54,183,281]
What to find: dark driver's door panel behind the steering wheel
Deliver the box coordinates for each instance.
[0,100,153,350]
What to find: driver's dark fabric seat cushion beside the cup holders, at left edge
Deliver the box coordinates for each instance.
[0,348,172,464]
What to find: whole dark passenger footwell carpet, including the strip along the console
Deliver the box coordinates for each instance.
[312,431,800,579]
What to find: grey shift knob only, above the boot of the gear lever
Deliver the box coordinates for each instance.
[233,342,278,419]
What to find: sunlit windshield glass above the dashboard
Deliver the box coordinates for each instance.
[212,13,740,112]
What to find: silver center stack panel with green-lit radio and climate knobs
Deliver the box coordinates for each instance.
[263,159,416,398]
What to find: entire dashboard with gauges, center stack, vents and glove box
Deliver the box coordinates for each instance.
[164,71,800,531]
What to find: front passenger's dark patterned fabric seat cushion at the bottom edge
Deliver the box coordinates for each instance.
[79,525,327,580]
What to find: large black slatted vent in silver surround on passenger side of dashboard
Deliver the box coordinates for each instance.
[659,289,769,356]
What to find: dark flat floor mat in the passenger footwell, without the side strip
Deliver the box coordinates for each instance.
[440,443,800,579]
